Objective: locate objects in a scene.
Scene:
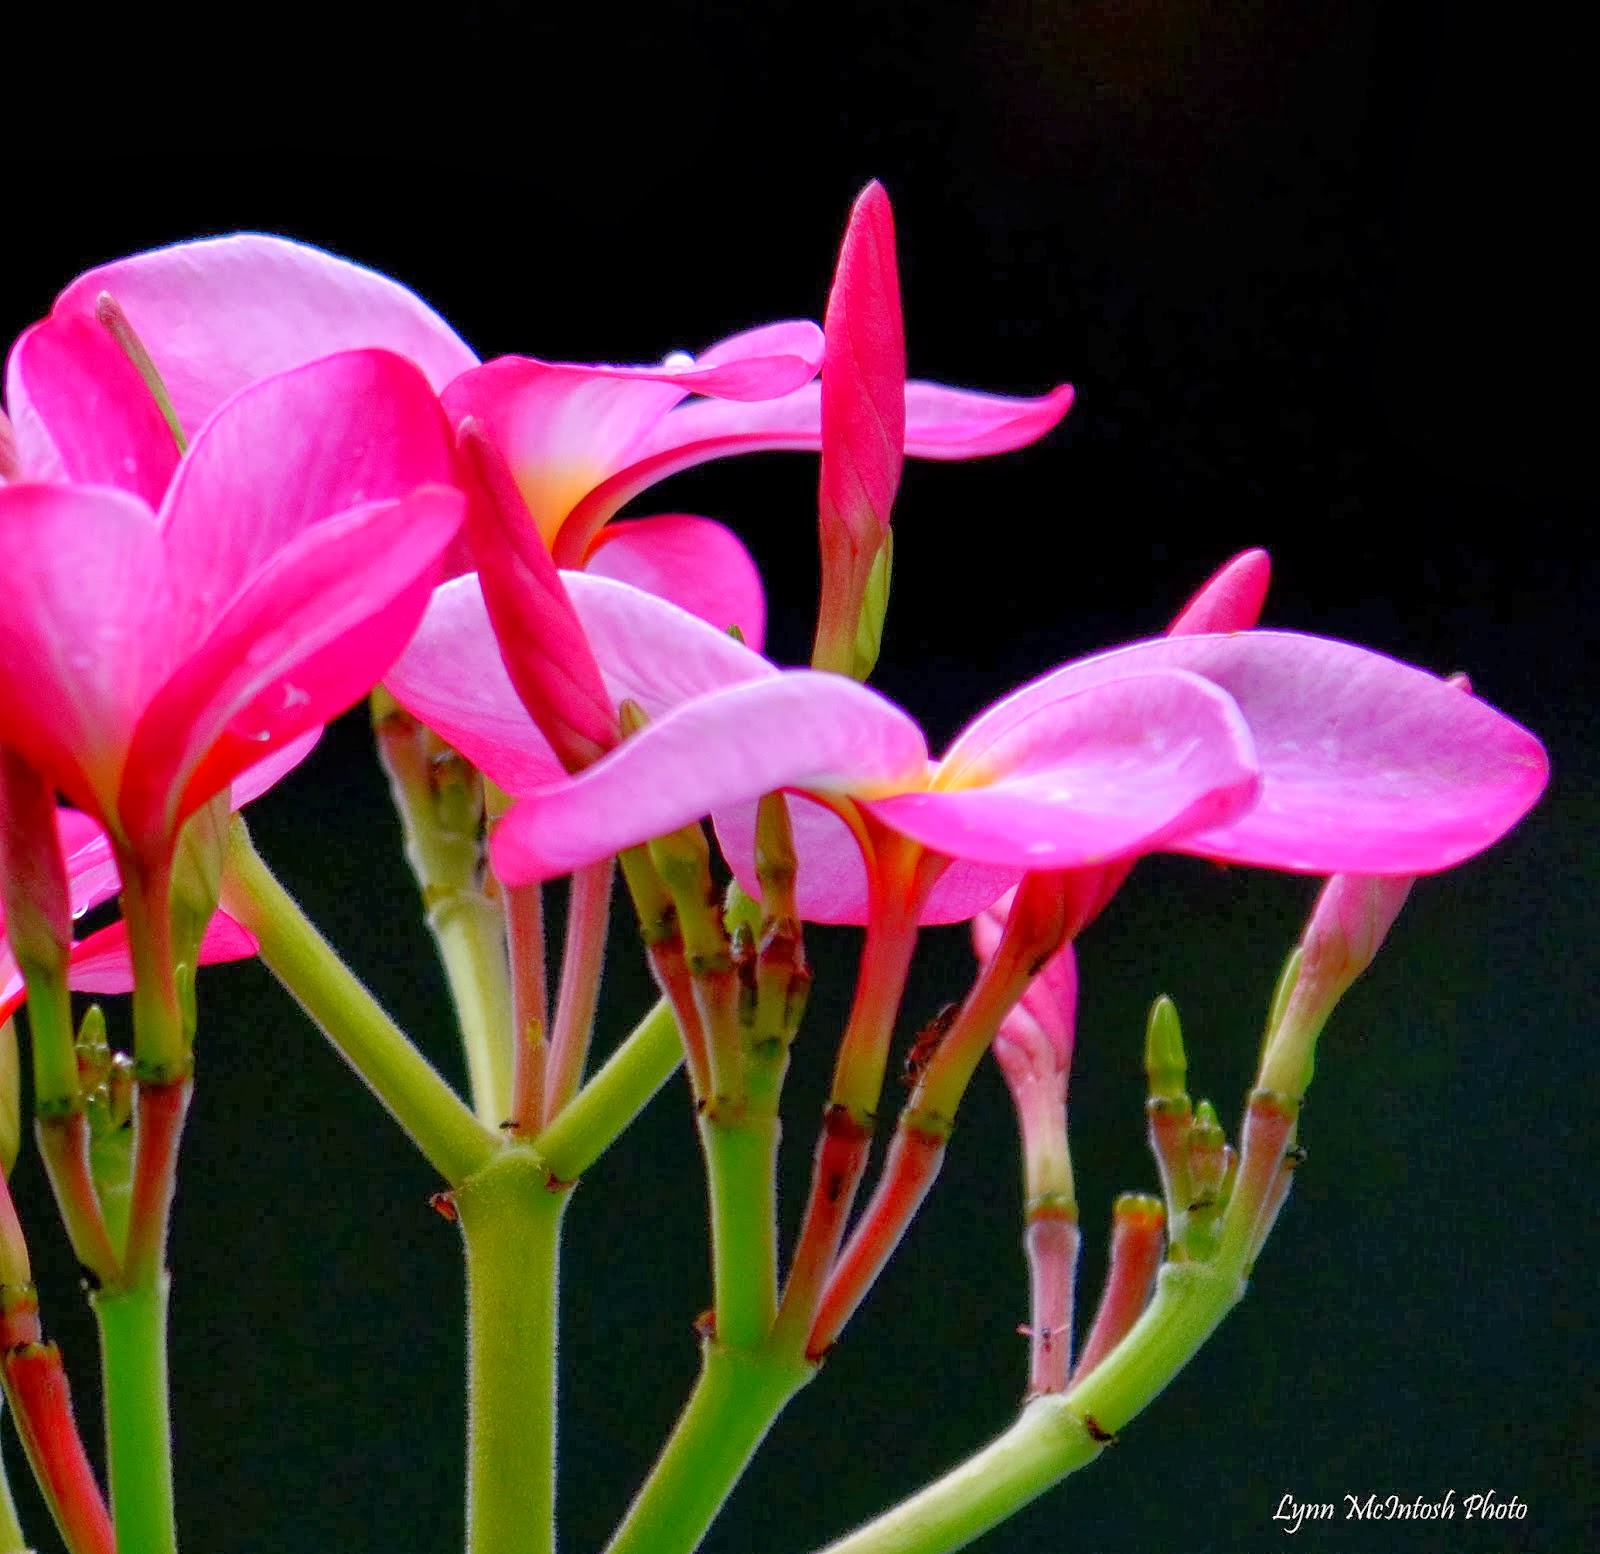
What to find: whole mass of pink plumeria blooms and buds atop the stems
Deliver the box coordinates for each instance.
[0,186,1546,1062]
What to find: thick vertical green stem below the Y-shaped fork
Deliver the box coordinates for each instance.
[454,1147,566,1554]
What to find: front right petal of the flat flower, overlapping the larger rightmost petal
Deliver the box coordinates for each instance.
[864,674,1256,869]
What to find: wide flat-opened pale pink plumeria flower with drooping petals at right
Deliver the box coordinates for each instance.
[390,576,1546,922]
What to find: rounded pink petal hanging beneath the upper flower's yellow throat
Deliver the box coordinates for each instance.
[584,512,766,651]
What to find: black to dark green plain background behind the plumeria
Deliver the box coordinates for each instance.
[0,0,1597,1554]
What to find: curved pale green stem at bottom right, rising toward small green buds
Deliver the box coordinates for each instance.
[806,1263,1245,1554]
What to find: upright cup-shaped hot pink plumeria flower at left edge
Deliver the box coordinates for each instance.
[0,340,464,872]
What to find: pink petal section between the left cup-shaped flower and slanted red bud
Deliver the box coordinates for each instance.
[384,573,565,794]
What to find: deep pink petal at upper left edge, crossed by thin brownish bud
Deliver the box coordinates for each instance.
[6,306,178,507]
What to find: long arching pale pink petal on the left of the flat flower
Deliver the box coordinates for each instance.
[493,669,928,885]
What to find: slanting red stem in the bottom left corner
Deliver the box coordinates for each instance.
[0,1285,117,1554]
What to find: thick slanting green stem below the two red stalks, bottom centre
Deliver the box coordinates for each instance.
[606,1341,816,1554]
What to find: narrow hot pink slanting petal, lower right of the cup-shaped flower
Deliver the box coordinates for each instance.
[120,487,464,839]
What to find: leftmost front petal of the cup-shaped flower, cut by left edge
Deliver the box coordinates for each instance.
[0,483,173,818]
